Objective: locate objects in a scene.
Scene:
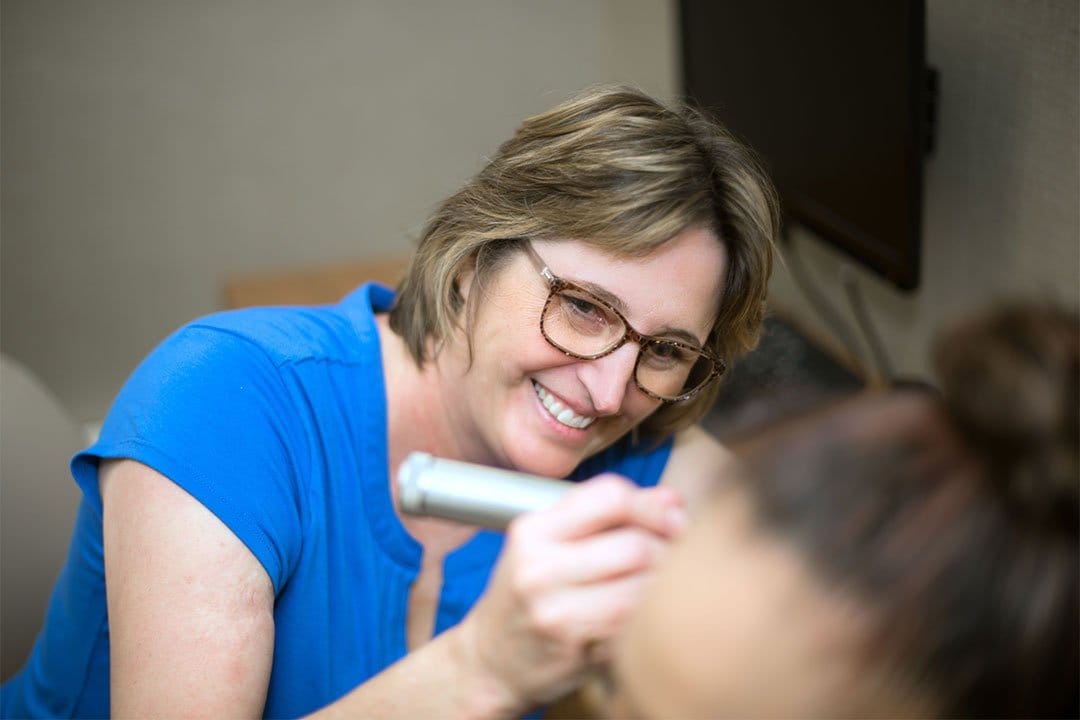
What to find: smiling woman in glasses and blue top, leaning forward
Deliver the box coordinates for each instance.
[0,86,779,718]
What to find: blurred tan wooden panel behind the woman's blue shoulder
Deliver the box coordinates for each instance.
[224,254,411,308]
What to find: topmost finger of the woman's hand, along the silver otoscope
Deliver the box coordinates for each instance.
[521,475,685,540]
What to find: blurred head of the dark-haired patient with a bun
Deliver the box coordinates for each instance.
[615,307,1080,718]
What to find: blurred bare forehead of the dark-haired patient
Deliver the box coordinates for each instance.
[616,488,864,718]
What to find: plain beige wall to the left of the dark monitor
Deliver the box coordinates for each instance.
[0,0,677,421]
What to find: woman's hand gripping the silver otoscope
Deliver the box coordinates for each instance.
[461,475,684,708]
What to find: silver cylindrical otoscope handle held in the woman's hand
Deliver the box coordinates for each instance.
[397,452,573,530]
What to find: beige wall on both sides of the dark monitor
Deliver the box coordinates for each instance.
[0,0,1080,420]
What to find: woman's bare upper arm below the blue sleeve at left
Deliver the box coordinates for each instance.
[100,460,274,718]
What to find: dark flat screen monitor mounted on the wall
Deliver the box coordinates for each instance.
[679,0,932,289]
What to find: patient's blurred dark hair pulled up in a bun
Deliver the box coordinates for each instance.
[741,304,1080,718]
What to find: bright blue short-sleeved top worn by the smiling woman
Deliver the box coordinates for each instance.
[0,285,672,718]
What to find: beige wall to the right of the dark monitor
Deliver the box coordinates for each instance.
[771,0,1080,376]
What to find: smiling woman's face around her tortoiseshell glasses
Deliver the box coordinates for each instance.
[413,228,724,477]
